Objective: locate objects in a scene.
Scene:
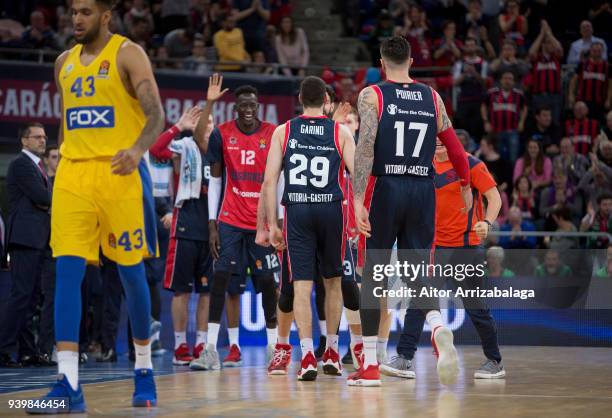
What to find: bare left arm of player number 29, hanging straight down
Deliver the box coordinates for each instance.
[261,125,286,249]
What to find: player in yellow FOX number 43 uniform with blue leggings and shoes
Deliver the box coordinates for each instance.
[28,0,164,413]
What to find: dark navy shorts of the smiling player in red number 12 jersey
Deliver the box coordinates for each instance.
[215,222,280,276]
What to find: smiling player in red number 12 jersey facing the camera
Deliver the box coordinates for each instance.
[196,84,279,370]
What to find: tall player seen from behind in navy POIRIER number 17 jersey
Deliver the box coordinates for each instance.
[348,37,472,386]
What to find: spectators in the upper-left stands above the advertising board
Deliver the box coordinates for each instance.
[0,0,309,75]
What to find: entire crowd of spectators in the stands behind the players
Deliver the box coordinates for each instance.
[0,0,612,245]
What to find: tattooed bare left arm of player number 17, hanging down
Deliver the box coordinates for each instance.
[353,87,378,202]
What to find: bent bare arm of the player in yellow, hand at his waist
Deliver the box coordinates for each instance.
[111,42,165,175]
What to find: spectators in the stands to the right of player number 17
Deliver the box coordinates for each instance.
[324,0,612,256]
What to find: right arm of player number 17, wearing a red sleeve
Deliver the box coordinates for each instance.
[432,89,473,212]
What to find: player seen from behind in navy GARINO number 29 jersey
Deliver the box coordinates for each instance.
[263,77,355,381]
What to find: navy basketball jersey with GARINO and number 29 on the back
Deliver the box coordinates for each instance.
[282,116,344,205]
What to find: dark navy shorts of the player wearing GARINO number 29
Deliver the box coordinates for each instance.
[285,201,345,280]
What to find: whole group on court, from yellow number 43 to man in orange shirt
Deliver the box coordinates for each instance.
[28,0,505,413]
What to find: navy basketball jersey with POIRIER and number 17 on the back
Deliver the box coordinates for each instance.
[372,81,438,178]
